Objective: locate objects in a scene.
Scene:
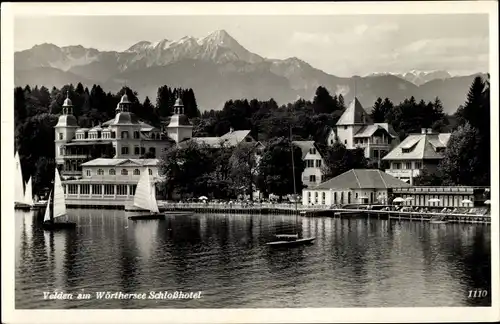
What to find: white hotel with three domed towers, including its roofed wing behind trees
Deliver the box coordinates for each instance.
[54,95,259,208]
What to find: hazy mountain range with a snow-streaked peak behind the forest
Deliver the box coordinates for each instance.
[14,30,482,113]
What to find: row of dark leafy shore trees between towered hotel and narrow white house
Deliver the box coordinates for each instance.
[160,137,304,199]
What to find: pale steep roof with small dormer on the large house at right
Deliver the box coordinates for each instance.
[382,133,450,160]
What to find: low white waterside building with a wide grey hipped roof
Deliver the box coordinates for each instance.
[302,169,410,206]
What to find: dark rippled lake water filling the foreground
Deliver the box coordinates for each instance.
[15,209,491,309]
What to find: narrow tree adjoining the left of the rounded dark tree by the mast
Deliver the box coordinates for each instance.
[229,143,260,200]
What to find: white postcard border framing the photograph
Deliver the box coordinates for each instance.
[1,1,500,323]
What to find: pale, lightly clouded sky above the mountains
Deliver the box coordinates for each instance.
[14,14,489,76]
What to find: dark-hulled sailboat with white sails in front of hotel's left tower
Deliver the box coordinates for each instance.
[43,168,76,230]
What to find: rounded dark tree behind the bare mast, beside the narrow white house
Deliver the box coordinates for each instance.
[259,137,305,199]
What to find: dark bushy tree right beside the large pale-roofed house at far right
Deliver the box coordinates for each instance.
[439,123,482,185]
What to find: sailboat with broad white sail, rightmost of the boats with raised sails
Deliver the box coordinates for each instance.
[129,168,164,219]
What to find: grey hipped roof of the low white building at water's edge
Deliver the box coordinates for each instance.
[313,169,410,190]
